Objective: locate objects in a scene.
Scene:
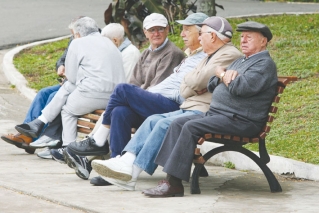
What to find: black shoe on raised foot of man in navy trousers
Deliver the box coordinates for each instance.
[68,137,110,156]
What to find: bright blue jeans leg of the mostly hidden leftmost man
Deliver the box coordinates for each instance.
[23,84,60,138]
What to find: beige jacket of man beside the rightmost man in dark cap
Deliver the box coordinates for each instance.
[180,43,242,112]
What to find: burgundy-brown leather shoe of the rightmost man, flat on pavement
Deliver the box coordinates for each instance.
[143,180,184,197]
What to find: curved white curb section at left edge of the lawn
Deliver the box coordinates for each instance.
[2,36,70,101]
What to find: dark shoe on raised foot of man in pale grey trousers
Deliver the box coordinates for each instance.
[15,119,44,138]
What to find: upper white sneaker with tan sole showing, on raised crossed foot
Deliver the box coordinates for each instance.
[92,158,133,181]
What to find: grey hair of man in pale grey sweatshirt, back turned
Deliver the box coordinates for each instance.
[72,17,99,37]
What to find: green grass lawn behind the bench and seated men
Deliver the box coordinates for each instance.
[14,14,319,164]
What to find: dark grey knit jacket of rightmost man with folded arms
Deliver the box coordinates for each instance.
[207,50,278,124]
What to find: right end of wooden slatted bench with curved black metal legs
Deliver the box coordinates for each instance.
[191,77,297,194]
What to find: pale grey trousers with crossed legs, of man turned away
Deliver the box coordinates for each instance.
[42,81,109,146]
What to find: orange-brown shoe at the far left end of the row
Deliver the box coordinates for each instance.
[1,133,35,154]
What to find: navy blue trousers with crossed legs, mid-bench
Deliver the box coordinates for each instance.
[102,84,179,157]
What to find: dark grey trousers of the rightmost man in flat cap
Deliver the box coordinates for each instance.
[155,110,262,181]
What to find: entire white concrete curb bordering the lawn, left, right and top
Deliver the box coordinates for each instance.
[3,12,319,181]
